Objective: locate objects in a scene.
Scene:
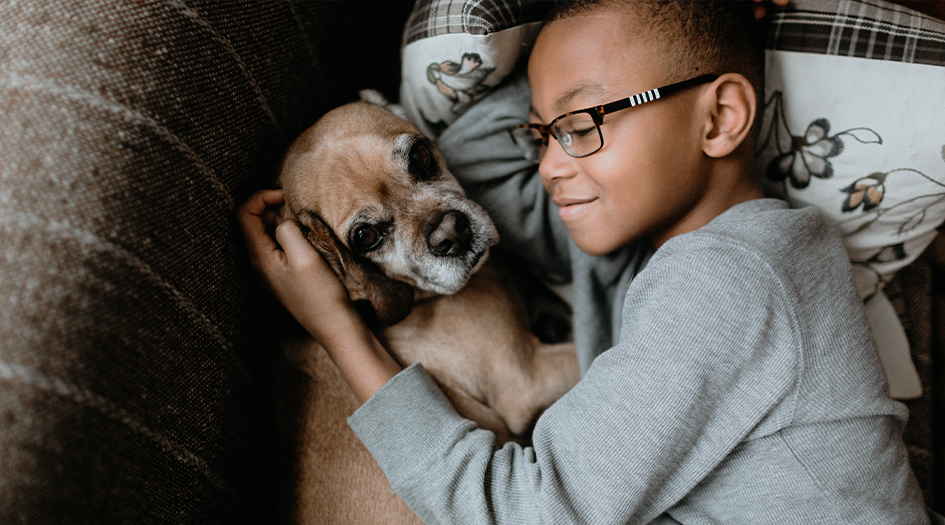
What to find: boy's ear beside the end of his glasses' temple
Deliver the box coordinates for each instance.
[702,73,758,158]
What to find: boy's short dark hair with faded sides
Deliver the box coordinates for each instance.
[546,0,764,96]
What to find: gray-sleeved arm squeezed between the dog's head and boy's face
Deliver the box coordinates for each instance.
[437,71,571,278]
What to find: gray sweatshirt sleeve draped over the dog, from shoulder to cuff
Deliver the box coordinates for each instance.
[349,237,799,525]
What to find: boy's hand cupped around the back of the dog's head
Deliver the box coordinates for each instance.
[237,190,360,344]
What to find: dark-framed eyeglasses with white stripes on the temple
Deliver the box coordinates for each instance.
[509,75,719,164]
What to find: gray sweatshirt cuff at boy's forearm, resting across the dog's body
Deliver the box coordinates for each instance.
[348,363,476,482]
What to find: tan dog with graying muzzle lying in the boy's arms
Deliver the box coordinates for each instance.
[279,92,579,525]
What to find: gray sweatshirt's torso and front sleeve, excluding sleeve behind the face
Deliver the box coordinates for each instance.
[349,200,928,525]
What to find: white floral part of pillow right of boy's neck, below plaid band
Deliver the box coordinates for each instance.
[756,51,945,398]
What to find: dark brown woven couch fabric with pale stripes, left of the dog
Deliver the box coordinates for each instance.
[0,0,410,524]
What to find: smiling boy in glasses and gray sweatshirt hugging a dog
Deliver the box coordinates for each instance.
[240,1,928,524]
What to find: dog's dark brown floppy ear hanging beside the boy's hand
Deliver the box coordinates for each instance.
[296,210,414,326]
